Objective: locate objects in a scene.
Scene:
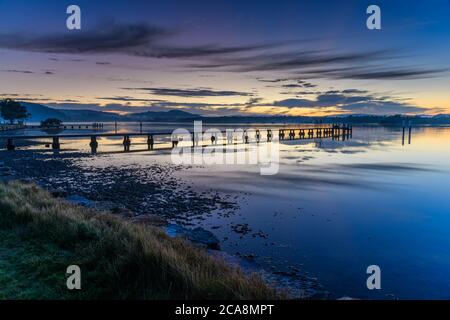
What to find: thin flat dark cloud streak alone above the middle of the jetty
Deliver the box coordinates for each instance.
[122,88,252,97]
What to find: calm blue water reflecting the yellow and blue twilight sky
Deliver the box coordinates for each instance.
[0,125,450,299]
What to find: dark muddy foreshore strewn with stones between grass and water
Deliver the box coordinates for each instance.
[0,150,330,299]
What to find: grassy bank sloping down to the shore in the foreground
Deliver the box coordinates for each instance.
[0,182,278,299]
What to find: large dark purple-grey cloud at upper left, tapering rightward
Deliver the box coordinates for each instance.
[0,23,312,61]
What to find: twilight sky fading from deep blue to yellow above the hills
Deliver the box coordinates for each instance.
[0,0,450,116]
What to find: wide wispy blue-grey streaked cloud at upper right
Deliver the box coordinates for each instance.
[189,50,448,80]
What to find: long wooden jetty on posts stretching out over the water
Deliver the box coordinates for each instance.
[0,125,353,153]
